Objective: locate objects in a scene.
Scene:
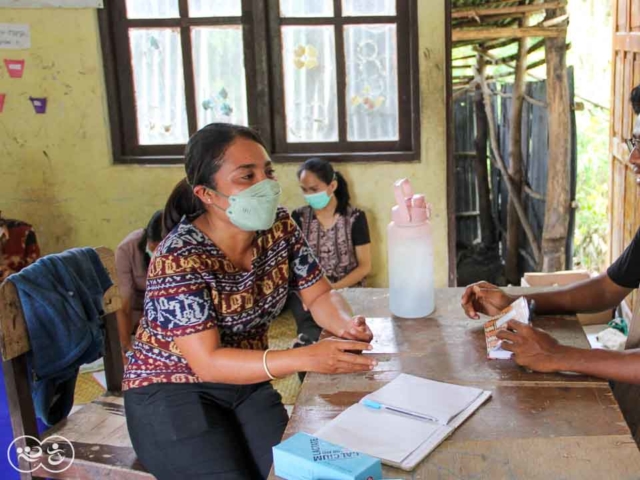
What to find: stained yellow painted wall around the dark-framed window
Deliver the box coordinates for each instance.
[0,0,449,286]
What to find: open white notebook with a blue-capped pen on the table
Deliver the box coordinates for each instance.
[314,373,491,470]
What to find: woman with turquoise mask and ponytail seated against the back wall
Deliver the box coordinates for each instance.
[289,158,371,346]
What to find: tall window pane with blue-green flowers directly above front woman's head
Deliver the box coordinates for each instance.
[191,25,248,128]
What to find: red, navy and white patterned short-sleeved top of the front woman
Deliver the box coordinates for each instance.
[123,208,323,390]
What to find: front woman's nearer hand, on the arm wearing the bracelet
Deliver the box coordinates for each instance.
[299,337,378,373]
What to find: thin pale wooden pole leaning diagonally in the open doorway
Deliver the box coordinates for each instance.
[476,57,542,265]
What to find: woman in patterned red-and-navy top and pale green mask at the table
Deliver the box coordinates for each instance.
[123,124,375,480]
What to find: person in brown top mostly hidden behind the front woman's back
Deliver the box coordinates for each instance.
[116,210,162,354]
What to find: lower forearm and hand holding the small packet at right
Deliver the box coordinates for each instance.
[497,320,640,384]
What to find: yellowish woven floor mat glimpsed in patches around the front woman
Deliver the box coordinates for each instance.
[73,312,300,405]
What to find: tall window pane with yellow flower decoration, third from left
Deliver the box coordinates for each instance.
[282,26,338,143]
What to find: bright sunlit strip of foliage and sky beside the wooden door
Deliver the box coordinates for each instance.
[567,0,612,272]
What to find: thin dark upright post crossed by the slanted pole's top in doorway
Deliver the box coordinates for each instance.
[473,55,495,246]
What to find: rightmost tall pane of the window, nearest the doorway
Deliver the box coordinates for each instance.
[344,25,399,142]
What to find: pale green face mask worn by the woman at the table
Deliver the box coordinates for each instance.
[210,179,282,232]
